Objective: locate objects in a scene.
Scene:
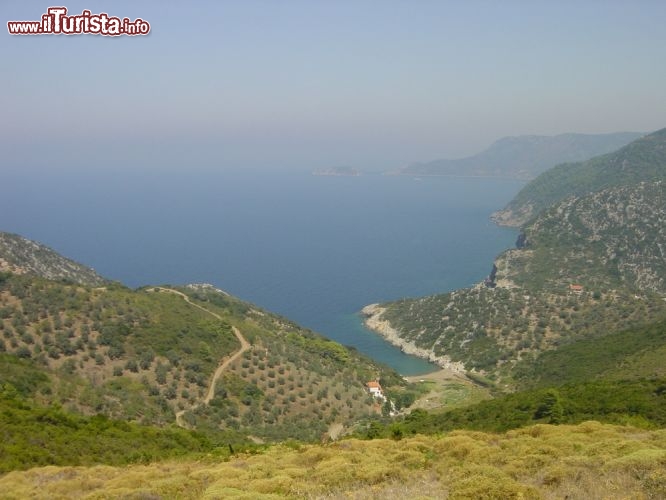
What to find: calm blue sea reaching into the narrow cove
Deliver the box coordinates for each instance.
[0,169,522,375]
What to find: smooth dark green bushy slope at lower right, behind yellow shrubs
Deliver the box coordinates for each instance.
[357,321,666,452]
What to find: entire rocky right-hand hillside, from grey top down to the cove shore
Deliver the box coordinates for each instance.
[366,182,666,383]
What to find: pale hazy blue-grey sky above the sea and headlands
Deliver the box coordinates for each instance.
[0,0,666,170]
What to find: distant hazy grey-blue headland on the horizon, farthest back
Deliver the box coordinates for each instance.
[399,132,643,179]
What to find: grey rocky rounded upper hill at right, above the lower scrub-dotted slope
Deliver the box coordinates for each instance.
[498,181,666,295]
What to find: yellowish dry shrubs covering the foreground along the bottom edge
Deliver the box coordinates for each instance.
[0,422,666,499]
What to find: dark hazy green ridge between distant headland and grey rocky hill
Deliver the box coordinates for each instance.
[493,129,666,226]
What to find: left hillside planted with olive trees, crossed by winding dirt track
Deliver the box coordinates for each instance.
[0,234,406,439]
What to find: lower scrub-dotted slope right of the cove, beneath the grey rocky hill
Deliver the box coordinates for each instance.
[374,285,666,376]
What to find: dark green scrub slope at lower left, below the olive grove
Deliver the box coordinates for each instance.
[0,384,213,474]
